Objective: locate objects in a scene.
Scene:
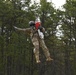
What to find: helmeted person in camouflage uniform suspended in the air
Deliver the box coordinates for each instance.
[14,21,53,63]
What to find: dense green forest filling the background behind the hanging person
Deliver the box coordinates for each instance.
[0,0,76,75]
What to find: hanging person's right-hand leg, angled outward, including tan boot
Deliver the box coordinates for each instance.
[40,39,53,61]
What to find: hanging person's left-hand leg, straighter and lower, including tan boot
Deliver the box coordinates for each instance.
[32,38,40,63]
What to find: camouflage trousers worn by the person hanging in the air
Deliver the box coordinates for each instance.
[32,38,50,61]
